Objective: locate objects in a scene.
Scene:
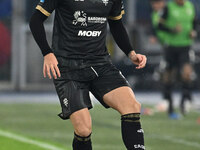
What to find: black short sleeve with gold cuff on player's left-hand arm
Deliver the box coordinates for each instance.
[36,0,59,17]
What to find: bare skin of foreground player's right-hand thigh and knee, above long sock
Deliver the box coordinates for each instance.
[103,86,140,115]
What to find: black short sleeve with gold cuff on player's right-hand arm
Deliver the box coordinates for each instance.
[108,0,125,20]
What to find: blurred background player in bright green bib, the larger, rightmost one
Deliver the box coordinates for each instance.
[158,0,196,119]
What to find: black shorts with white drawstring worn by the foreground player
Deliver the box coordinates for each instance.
[54,58,129,119]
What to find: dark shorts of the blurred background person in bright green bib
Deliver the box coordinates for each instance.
[164,46,190,70]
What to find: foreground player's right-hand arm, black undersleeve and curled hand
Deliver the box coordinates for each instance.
[108,18,147,69]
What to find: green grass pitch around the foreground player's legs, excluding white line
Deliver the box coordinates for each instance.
[0,104,200,150]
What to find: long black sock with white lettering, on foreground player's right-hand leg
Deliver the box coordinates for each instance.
[121,113,145,150]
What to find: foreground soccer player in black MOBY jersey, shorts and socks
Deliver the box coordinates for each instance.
[30,0,147,150]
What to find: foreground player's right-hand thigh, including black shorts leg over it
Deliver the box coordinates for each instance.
[91,64,140,114]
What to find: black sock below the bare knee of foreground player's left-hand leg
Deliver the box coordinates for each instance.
[72,133,92,150]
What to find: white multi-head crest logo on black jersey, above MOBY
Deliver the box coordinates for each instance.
[73,11,87,26]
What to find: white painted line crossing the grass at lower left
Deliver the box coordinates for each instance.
[0,130,64,150]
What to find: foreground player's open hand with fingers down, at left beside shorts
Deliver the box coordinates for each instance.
[43,53,61,79]
